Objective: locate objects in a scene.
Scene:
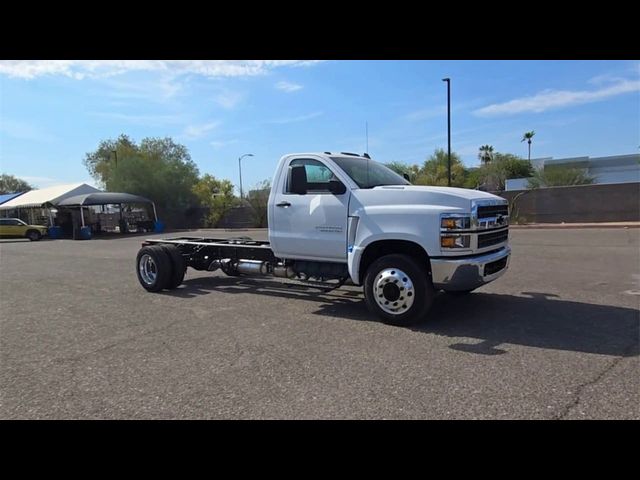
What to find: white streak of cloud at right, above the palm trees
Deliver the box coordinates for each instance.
[474,76,640,117]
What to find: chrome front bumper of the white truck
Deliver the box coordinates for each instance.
[431,245,511,291]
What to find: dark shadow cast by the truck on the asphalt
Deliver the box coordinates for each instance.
[165,276,640,357]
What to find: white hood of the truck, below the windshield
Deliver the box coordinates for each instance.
[350,185,506,214]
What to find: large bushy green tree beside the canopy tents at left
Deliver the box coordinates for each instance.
[83,135,198,220]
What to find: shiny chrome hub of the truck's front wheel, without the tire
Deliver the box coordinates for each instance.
[373,268,416,315]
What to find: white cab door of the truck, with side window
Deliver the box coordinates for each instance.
[269,158,350,262]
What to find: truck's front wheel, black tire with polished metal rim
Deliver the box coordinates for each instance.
[364,254,435,326]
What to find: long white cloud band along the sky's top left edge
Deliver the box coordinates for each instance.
[0,60,318,80]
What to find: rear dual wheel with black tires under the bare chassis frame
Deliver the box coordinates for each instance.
[136,245,187,292]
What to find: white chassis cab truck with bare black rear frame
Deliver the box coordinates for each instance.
[136,152,511,325]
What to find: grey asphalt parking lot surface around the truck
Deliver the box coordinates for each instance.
[0,229,640,419]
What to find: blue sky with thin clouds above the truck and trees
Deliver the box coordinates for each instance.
[0,60,640,189]
